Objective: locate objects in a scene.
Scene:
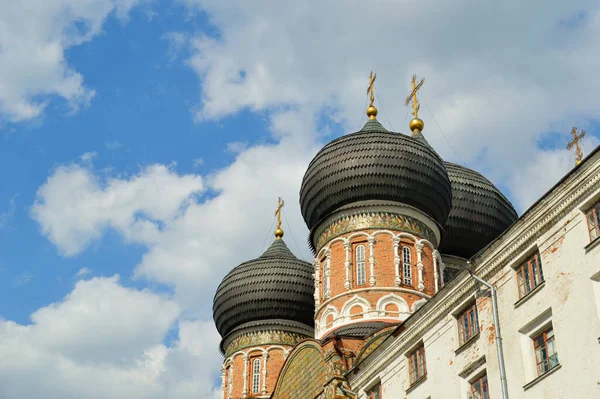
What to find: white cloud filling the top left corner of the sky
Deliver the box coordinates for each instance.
[0,0,140,122]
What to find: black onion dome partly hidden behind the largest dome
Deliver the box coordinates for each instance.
[439,162,518,258]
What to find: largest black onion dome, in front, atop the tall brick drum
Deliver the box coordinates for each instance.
[300,120,452,230]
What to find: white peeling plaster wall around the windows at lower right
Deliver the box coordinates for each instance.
[348,152,600,399]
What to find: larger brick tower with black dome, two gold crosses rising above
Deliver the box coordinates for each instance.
[300,74,452,339]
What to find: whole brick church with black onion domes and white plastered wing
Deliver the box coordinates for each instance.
[213,75,600,399]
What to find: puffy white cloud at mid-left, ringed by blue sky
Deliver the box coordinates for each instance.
[31,164,203,256]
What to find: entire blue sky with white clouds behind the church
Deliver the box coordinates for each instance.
[0,0,600,399]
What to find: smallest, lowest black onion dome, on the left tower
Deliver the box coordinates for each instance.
[213,239,315,338]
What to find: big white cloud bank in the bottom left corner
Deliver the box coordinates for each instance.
[0,277,219,399]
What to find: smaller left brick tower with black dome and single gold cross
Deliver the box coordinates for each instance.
[213,206,314,399]
